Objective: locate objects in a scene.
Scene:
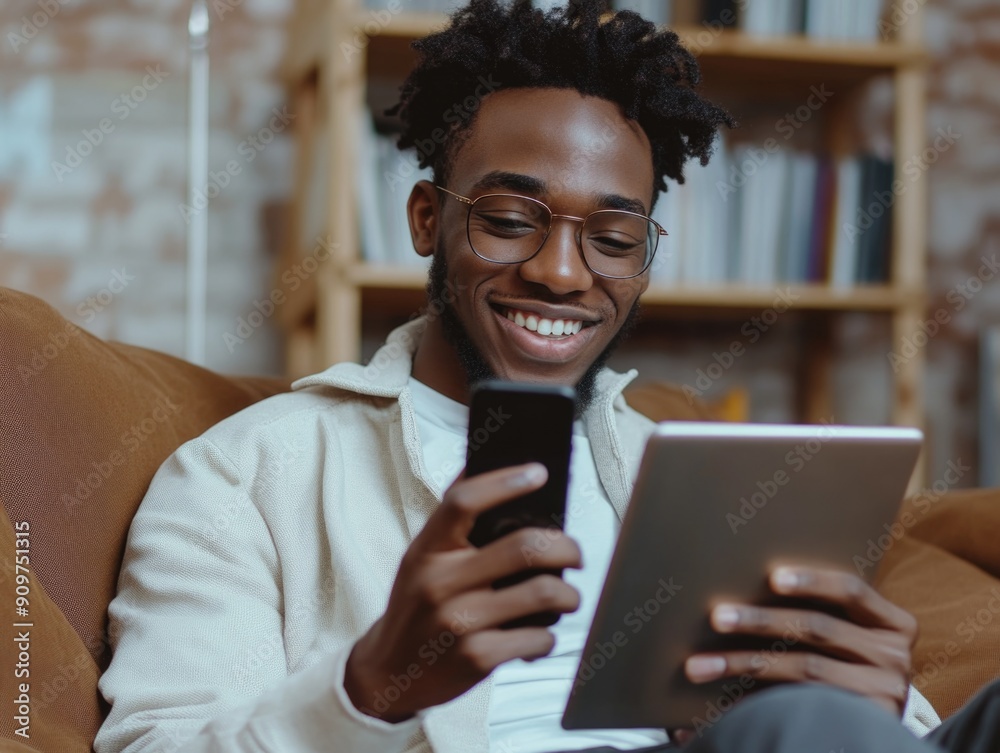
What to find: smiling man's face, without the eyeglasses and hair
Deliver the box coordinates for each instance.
[418,89,653,396]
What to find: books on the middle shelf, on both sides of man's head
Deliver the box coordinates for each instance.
[356,116,896,287]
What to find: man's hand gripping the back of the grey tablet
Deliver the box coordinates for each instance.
[685,566,917,715]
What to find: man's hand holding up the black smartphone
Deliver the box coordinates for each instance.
[344,463,581,722]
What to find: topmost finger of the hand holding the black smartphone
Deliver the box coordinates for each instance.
[414,463,548,551]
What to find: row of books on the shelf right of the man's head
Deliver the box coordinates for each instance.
[652,137,895,287]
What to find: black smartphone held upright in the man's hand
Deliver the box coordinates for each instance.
[465,380,576,628]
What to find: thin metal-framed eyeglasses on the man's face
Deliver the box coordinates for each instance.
[435,186,667,280]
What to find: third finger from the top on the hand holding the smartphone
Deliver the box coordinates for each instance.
[447,573,580,631]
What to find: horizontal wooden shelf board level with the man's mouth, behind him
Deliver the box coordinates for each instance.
[347,264,921,312]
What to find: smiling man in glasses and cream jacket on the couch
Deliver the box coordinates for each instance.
[95,0,995,753]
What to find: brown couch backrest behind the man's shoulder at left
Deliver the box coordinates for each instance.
[0,288,288,680]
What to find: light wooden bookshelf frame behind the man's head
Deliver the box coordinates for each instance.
[276,0,928,438]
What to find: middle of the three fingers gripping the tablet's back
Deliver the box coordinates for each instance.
[711,604,910,672]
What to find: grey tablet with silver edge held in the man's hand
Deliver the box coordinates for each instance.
[562,422,923,729]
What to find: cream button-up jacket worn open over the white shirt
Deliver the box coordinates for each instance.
[95,320,933,753]
